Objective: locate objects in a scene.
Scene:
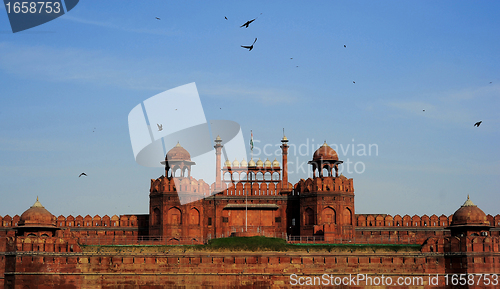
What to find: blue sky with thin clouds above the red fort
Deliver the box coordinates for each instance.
[0,0,500,216]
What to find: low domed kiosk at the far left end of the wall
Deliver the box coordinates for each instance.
[17,197,59,237]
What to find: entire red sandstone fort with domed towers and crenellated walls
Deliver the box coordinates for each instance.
[0,137,500,289]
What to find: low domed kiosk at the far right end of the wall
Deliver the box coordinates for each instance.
[449,196,491,237]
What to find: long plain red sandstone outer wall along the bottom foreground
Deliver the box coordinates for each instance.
[0,237,500,289]
